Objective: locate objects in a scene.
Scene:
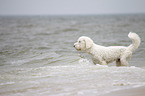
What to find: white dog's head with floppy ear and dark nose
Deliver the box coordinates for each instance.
[74,36,93,51]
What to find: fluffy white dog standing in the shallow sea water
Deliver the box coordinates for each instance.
[74,32,140,66]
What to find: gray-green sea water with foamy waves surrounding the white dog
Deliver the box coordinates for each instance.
[0,15,145,96]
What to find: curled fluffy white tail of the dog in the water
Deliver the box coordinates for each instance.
[128,32,140,51]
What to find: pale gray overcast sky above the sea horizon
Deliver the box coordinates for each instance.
[0,0,145,15]
